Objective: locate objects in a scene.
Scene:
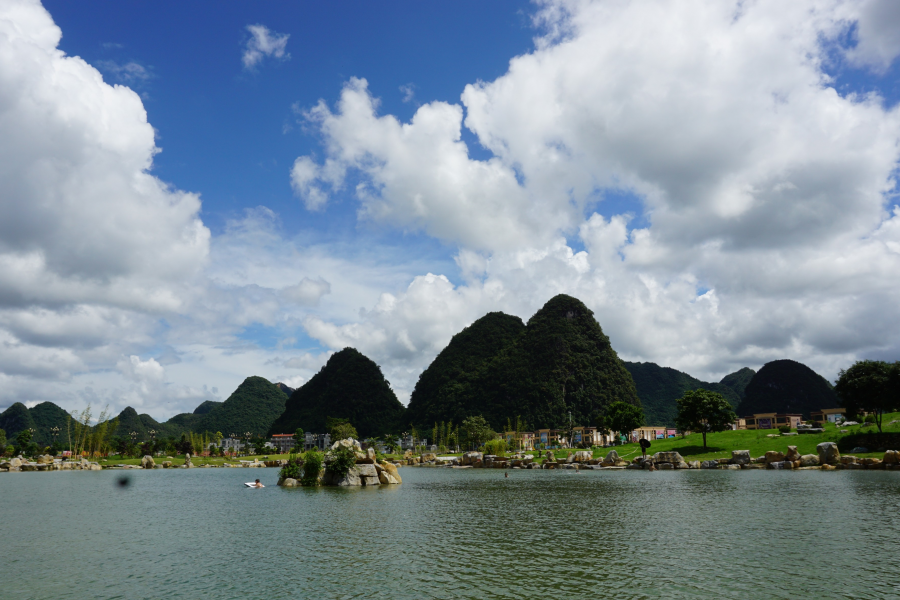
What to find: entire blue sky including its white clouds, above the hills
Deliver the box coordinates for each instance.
[0,0,900,418]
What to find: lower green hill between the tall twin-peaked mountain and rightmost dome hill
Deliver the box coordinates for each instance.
[625,362,741,427]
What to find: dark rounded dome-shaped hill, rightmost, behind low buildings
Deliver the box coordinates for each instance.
[737,360,839,418]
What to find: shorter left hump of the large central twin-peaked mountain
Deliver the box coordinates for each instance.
[404,312,525,430]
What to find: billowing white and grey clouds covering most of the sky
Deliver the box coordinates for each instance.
[0,0,900,417]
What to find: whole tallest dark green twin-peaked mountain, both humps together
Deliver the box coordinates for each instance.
[407,294,640,431]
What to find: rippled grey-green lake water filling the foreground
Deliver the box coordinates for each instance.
[0,468,900,600]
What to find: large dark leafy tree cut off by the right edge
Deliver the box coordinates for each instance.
[834,360,900,432]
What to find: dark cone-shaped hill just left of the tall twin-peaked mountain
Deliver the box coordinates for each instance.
[269,348,405,438]
